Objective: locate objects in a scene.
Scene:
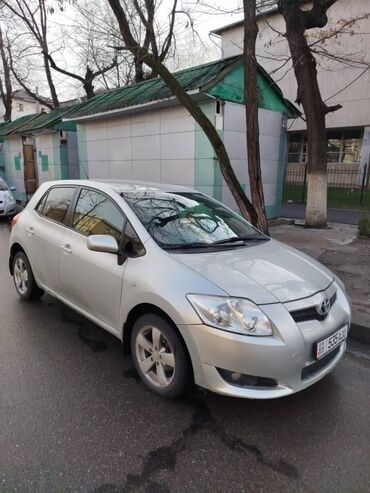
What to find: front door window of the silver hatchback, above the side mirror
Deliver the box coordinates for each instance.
[73,189,125,242]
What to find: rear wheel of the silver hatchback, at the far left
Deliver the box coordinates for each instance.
[12,252,44,301]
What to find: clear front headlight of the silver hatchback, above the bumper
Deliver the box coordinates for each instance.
[187,294,272,336]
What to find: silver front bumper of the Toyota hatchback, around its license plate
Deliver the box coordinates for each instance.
[179,285,350,399]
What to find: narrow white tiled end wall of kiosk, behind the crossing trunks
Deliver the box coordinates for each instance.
[222,103,282,208]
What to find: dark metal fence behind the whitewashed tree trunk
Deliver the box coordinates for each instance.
[283,165,370,209]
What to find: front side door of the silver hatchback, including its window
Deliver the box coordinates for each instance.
[60,188,126,331]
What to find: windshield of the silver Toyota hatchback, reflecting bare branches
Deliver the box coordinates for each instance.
[121,192,268,249]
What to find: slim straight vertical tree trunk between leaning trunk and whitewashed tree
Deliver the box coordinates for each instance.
[244,0,268,234]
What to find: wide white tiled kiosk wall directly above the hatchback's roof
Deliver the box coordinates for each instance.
[85,106,195,186]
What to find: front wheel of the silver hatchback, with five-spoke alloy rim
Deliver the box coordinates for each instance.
[131,314,192,399]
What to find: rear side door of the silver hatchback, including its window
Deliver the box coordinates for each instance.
[24,185,77,294]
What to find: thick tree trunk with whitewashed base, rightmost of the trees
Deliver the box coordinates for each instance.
[280,0,339,228]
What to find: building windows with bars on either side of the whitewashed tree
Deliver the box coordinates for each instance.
[288,130,362,164]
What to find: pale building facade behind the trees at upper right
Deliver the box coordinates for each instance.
[213,0,370,177]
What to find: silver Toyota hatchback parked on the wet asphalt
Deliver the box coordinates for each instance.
[9,180,351,399]
